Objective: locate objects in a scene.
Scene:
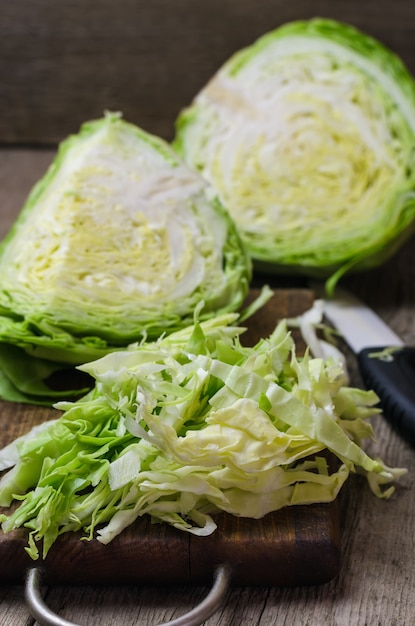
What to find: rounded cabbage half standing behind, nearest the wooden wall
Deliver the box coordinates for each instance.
[174,19,415,289]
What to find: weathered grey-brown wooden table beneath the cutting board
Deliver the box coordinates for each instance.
[0,149,415,626]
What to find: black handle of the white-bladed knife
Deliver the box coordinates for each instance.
[357,346,415,444]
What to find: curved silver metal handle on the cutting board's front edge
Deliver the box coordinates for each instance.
[25,565,230,626]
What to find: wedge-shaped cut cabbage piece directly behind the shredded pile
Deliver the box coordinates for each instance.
[0,114,251,404]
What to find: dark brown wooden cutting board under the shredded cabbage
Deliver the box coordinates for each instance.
[0,289,340,586]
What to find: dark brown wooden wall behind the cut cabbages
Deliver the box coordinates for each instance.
[0,0,415,144]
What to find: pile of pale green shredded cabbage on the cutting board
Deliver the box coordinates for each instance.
[0,306,405,559]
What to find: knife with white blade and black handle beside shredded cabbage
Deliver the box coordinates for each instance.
[314,288,415,444]
